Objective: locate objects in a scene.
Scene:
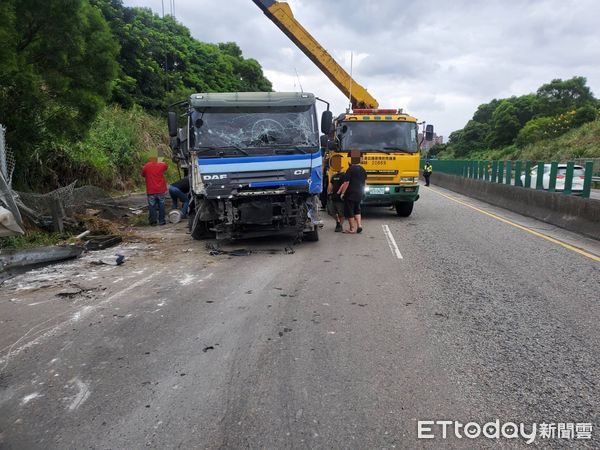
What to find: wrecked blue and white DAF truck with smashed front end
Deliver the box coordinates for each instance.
[168,92,332,241]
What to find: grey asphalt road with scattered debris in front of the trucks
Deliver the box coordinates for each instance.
[0,183,600,449]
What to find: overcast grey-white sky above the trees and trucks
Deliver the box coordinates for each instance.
[125,0,600,137]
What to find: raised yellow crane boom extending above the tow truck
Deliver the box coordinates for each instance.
[252,0,379,109]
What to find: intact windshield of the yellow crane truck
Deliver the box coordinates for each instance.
[339,122,417,153]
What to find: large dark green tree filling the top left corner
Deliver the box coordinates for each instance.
[0,0,118,186]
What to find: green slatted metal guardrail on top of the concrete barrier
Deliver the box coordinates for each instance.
[421,159,600,198]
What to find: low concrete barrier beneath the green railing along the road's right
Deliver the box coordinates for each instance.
[431,173,600,240]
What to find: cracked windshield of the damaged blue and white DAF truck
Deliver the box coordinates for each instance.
[192,105,319,156]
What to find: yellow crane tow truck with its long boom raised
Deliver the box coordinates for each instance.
[252,0,433,217]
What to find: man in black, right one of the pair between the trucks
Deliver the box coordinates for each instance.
[338,150,367,234]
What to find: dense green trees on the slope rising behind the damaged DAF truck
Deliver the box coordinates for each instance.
[91,0,272,113]
